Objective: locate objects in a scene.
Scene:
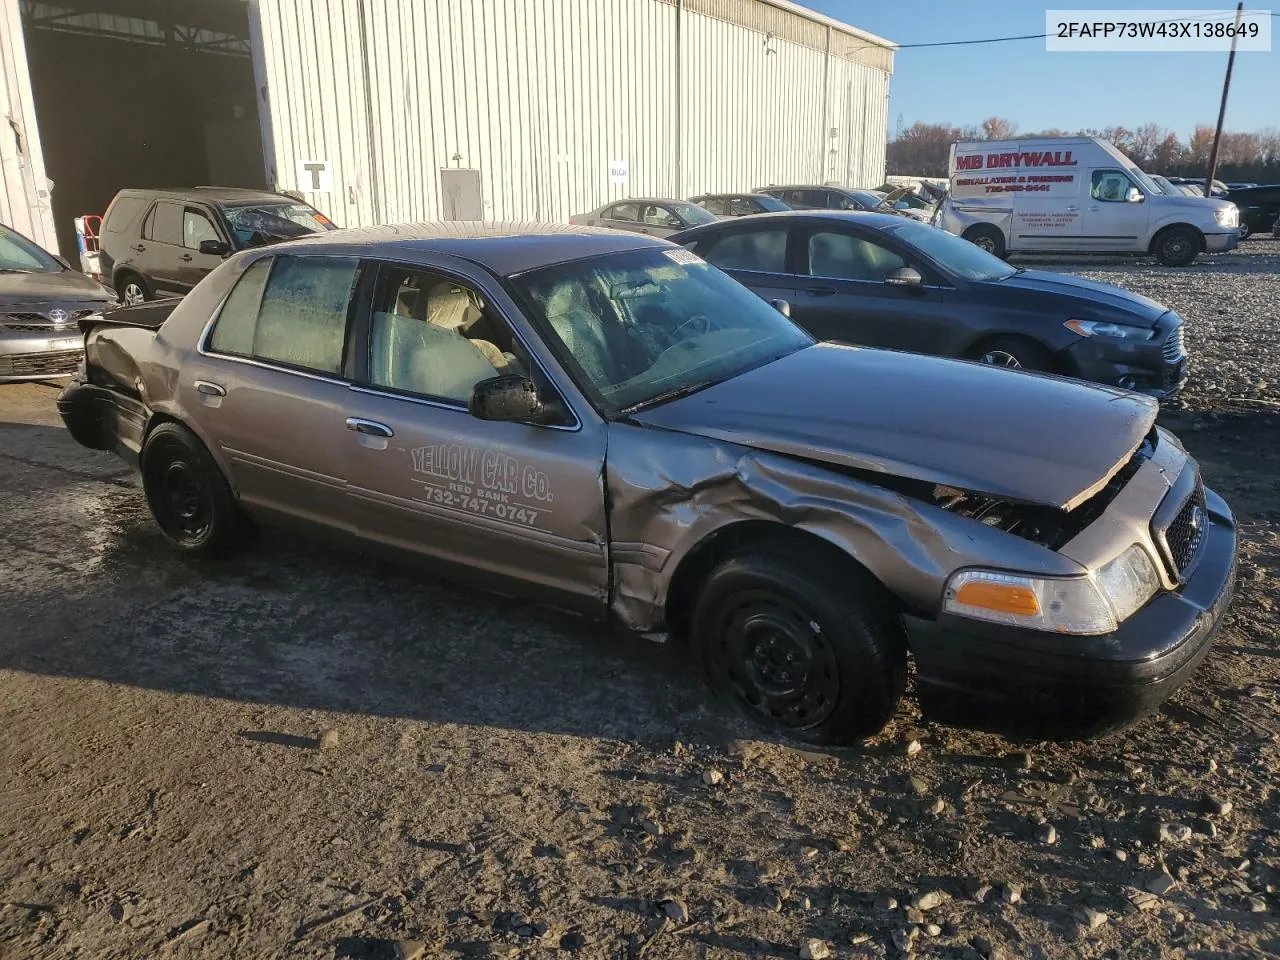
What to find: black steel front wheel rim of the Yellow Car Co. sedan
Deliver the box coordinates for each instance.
[712,590,840,730]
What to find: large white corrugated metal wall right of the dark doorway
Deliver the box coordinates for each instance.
[250,0,888,225]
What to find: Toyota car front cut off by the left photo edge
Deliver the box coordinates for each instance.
[0,224,115,383]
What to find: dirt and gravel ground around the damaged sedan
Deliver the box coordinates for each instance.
[0,241,1280,960]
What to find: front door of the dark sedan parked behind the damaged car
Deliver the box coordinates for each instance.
[791,223,948,353]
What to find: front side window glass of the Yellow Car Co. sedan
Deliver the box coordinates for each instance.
[369,266,530,404]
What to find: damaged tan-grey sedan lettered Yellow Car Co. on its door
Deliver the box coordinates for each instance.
[59,223,1236,742]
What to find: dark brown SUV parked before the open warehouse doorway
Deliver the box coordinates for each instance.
[102,187,334,303]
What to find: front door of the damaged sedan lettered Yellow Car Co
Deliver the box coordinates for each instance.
[346,264,608,612]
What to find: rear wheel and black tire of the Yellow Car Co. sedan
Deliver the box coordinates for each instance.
[142,422,252,558]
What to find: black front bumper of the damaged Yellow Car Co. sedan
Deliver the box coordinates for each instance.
[904,489,1236,739]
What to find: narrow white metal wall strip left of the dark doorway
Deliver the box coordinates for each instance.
[0,0,58,251]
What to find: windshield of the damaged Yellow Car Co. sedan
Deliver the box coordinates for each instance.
[512,248,814,412]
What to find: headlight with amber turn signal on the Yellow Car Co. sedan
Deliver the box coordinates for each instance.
[942,544,1160,635]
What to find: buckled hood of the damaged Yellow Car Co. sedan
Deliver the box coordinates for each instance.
[634,343,1158,509]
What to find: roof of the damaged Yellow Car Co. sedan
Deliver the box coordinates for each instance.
[271,220,671,276]
